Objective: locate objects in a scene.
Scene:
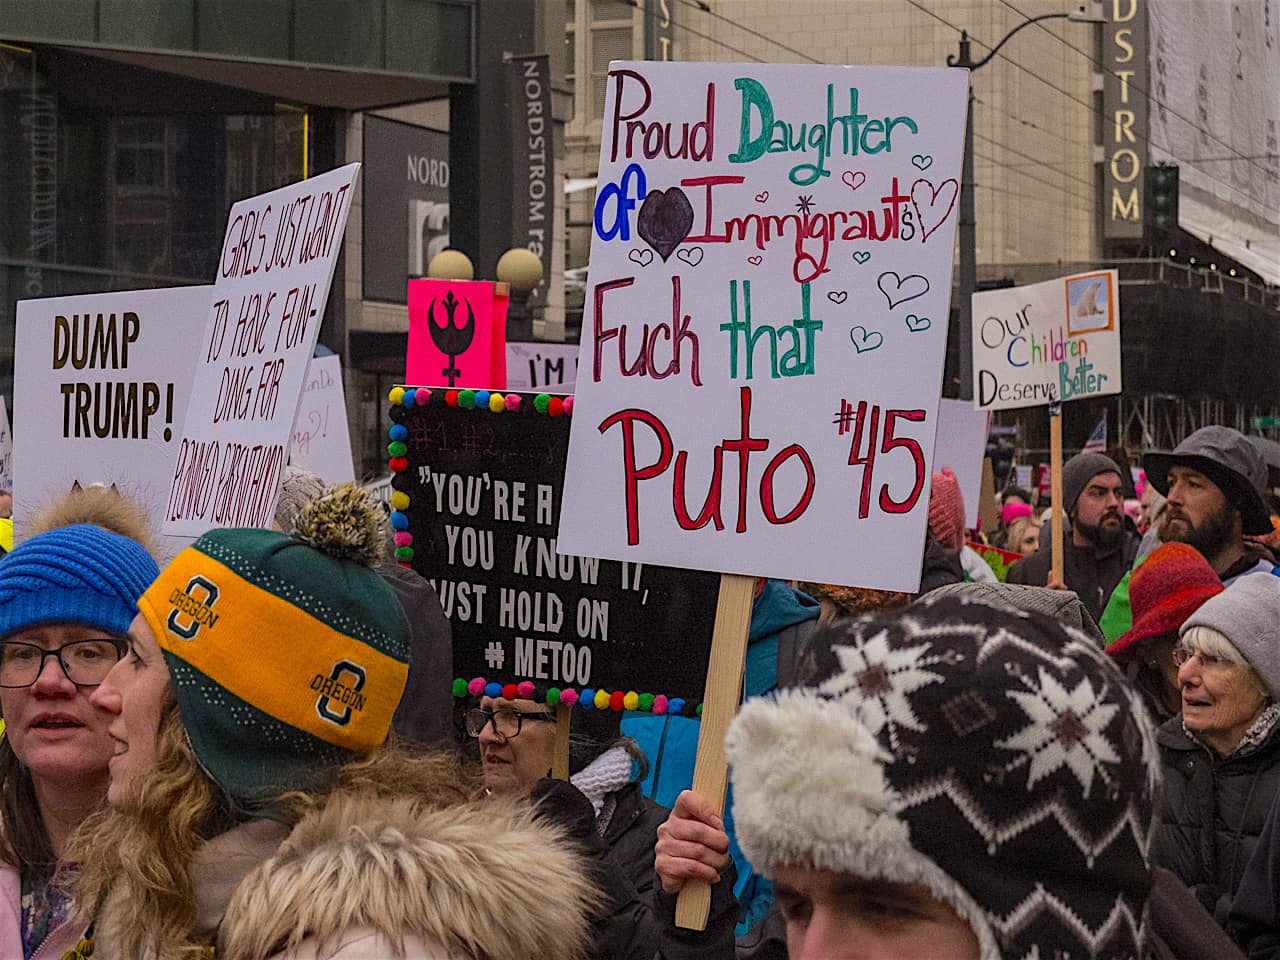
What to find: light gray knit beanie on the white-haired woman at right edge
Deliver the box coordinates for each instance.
[1181,573,1280,700]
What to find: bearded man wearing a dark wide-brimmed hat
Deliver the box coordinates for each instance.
[1143,425,1277,586]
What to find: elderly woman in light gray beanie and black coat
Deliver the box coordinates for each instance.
[1156,576,1280,923]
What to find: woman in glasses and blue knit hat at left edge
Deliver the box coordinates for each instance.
[0,524,159,960]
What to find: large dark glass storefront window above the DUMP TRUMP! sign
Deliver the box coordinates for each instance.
[0,47,310,414]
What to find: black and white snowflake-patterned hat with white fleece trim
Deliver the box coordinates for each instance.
[724,596,1160,960]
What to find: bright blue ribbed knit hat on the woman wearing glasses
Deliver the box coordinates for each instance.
[0,524,160,636]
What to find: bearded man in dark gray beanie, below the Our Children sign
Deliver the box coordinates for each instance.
[1006,453,1139,620]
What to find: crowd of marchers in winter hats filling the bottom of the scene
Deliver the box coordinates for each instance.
[0,426,1280,960]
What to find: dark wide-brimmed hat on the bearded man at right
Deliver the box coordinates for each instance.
[1142,424,1271,536]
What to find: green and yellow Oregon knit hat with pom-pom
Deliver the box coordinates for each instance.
[138,484,410,808]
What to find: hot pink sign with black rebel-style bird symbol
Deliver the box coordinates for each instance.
[404,279,509,389]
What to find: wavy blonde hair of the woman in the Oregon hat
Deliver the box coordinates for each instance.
[65,707,480,960]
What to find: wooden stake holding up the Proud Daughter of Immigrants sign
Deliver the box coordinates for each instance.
[676,573,755,931]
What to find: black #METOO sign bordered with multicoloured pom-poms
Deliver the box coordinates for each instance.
[390,388,719,714]
